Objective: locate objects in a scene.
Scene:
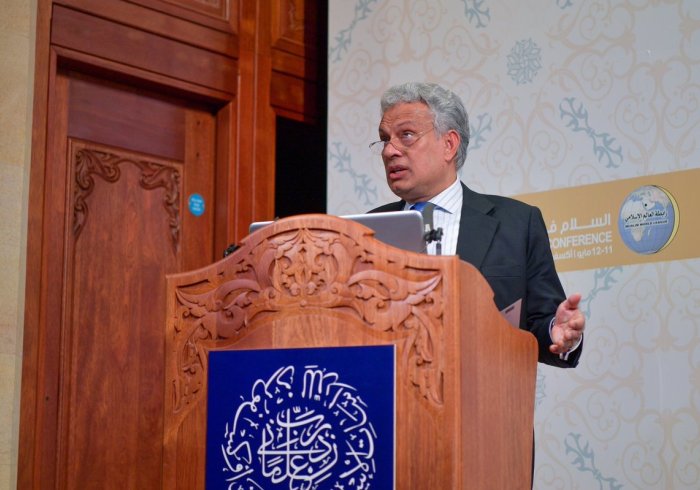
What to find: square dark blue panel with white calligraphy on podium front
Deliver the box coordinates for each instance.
[206,346,395,490]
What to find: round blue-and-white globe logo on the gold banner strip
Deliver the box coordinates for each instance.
[617,185,678,255]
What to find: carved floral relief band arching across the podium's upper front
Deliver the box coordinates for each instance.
[168,215,443,420]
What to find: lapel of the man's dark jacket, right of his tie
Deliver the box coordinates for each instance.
[457,184,499,269]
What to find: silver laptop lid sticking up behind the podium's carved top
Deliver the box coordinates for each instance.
[248,211,425,253]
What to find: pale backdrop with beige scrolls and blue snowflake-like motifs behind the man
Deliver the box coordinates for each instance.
[328,0,700,489]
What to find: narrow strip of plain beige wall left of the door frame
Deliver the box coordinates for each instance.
[0,0,36,489]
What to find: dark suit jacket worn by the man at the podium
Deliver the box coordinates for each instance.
[370,184,583,367]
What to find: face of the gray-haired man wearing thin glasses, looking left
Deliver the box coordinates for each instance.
[379,102,459,202]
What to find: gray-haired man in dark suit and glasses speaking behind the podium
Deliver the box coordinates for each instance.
[370,83,585,367]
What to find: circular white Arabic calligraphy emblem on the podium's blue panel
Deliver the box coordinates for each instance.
[221,365,377,490]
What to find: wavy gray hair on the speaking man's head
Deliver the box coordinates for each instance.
[380,82,469,170]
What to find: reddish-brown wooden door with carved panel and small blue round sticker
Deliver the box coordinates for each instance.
[41,72,218,488]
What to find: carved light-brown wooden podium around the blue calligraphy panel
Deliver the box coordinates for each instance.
[163,215,537,490]
